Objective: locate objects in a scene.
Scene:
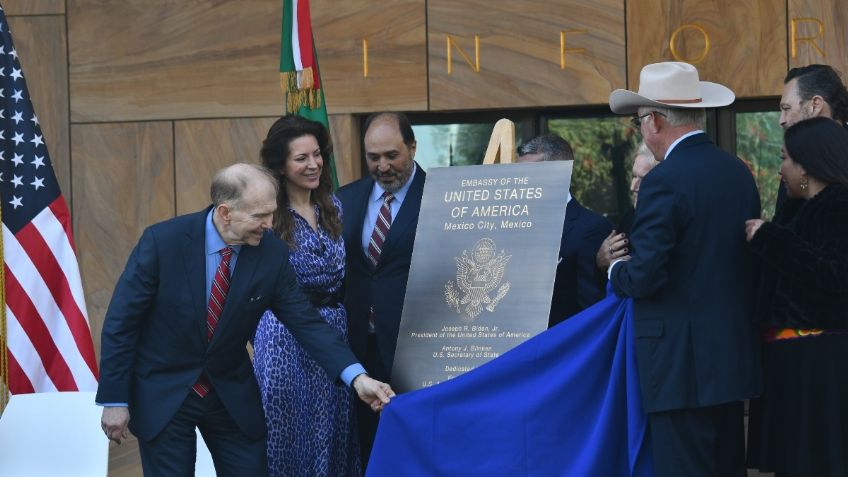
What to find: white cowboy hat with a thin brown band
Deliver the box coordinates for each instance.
[610,61,736,114]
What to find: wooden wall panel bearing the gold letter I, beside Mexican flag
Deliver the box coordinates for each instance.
[311,0,427,113]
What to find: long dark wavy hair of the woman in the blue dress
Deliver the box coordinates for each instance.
[259,115,342,244]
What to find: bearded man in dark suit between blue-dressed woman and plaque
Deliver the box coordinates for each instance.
[338,113,426,463]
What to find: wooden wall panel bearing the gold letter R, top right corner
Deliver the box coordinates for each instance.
[787,0,848,75]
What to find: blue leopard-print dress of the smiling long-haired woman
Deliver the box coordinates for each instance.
[254,197,361,477]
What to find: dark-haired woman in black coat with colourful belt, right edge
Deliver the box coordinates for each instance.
[745,118,848,477]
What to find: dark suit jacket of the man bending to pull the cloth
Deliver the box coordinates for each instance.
[96,209,356,440]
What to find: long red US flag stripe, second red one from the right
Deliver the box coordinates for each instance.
[17,218,97,374]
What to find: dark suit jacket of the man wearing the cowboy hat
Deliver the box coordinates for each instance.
[611,134,761,412]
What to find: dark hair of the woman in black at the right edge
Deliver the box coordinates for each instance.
[783,117,848,186]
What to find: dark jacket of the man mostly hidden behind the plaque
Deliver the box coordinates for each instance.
[548,197,612,327]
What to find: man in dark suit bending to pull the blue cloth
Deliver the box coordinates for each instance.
[96,164,393,476]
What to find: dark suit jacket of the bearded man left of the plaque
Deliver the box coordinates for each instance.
[336,167,426,378]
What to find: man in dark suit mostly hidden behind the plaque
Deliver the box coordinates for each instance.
[518,134,612,328]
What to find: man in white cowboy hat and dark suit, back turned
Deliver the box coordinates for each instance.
[609,62,761,477]
